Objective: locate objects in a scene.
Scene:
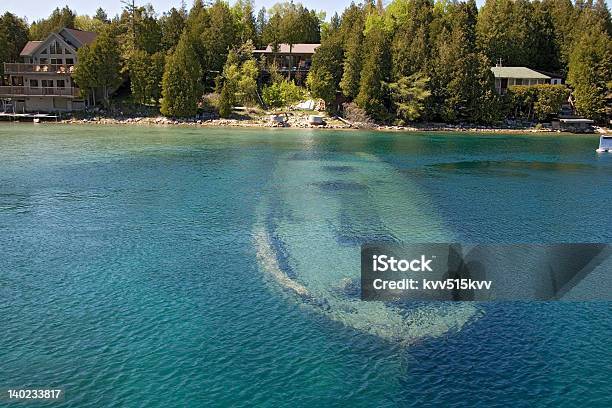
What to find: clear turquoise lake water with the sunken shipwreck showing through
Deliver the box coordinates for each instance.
[0,124,612,407]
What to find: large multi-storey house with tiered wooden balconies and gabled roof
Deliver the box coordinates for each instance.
[0,28,96,113]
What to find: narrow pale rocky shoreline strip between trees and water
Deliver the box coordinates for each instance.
[0,116,609,135]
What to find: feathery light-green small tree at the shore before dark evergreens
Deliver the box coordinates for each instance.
[388,73,431,121]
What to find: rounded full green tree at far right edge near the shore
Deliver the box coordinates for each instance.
[567,26,612,119]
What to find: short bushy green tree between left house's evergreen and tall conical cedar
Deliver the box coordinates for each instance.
[128,50,165,104]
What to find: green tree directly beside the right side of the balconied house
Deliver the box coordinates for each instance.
[74,25,122,106]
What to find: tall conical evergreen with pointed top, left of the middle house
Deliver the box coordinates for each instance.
[161,35,202,117]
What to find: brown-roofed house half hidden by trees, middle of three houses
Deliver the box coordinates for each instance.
[253,44,321,77]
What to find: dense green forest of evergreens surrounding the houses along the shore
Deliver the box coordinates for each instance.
[0,0,612,123]
